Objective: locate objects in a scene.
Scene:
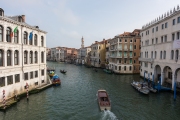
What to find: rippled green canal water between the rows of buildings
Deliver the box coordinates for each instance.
[0,62,180,120]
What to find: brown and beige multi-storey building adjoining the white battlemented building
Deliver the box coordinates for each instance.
[109,29,141,74]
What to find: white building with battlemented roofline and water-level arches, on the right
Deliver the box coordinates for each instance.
[139,6,180,89]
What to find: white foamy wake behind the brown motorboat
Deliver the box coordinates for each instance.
[101,110,118,120]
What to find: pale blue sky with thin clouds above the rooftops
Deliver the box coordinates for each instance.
[0,0,180,49]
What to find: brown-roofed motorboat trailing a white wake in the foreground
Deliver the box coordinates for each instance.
[97,90,111,111]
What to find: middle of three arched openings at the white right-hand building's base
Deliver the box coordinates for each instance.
[162,66,173,88]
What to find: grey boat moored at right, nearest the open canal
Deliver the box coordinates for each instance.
[131,81,149,95]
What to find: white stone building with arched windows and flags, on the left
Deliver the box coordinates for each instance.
[0,9,47,101]
